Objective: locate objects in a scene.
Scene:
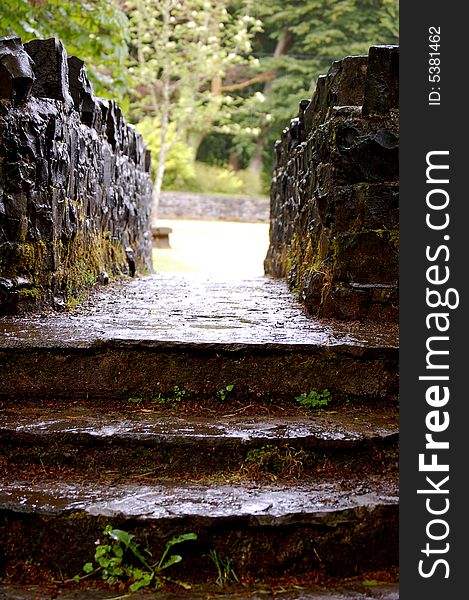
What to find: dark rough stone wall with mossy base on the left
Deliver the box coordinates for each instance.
[0,37,152,313]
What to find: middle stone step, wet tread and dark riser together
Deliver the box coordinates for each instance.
[0,405,398,479]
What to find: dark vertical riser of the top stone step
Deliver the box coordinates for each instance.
[0,340,399,401]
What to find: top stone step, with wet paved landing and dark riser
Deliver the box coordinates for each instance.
[0,273,398,402]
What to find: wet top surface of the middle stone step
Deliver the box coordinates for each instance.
[0,405,398,448]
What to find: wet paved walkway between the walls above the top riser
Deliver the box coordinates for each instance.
[0,273,398,348]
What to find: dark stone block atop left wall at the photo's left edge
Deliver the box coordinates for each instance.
[0,37,36,104]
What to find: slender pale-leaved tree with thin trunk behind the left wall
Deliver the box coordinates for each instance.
[126,0,261,213]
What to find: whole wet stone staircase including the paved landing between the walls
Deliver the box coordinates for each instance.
[0,273,398,600]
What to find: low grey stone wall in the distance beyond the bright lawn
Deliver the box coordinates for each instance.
[157,191,270,223]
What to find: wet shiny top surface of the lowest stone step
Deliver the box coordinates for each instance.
[0,479,397,525]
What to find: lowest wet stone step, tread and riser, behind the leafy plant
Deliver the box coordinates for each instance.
[0,479,398,582]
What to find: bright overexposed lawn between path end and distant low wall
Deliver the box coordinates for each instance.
[153,219,269,278]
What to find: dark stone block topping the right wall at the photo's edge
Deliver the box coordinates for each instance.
[363,46,399,116]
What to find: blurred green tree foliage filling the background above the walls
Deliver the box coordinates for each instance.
[0,0,399,193]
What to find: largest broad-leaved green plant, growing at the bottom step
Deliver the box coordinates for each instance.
[74,525,197,592]
